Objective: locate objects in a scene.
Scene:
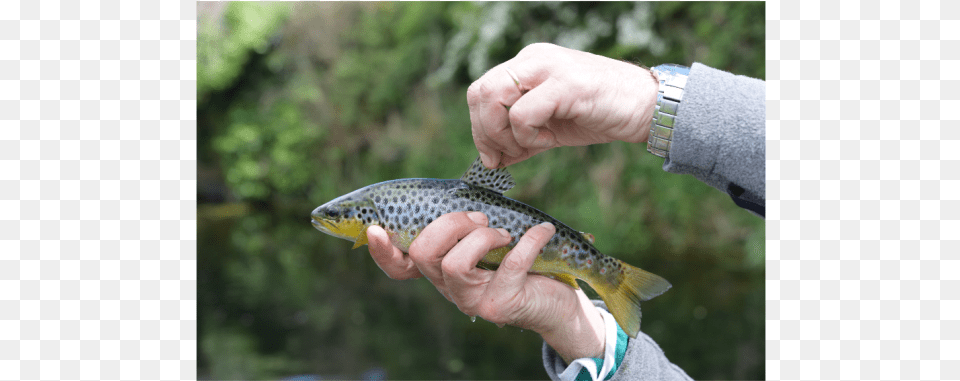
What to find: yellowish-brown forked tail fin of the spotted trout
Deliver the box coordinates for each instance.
[590,261,671,338]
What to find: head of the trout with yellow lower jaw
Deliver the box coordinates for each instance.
[310,192,380,247]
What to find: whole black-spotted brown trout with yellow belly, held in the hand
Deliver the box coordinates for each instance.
[311,158,670,337]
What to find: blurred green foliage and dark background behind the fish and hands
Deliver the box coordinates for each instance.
[197,2,765,379]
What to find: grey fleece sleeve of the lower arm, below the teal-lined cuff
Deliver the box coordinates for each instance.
[543,300,691,381]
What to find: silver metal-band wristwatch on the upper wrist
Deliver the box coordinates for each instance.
[647,64,690,158]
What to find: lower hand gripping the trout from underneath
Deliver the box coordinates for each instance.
[367,212,604,363]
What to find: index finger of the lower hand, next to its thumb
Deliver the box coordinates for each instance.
[410,212,487,292]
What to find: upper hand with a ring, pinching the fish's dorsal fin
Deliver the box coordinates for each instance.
[467,43,657,168]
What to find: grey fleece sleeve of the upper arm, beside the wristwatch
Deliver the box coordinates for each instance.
[663,63,767,216]
